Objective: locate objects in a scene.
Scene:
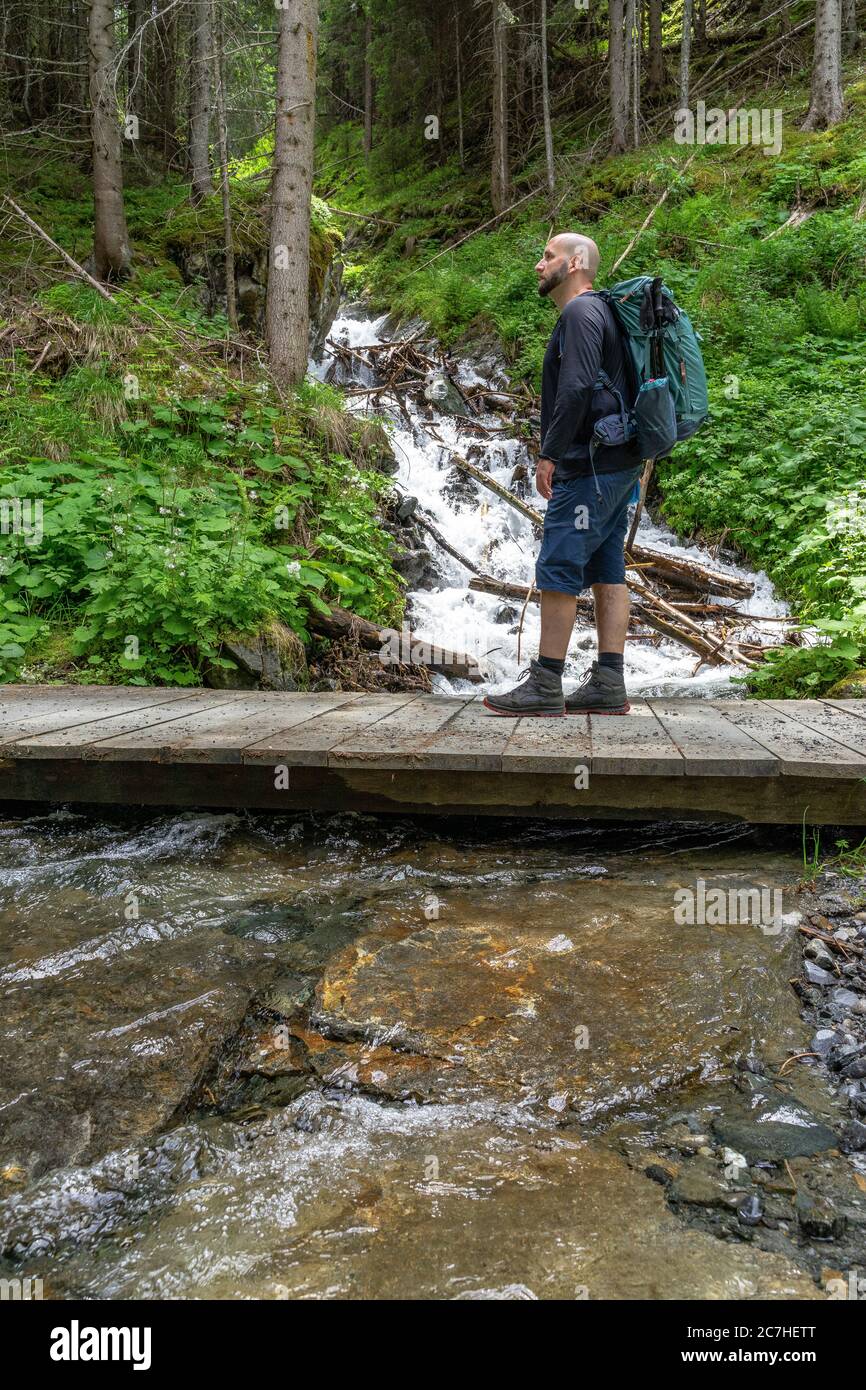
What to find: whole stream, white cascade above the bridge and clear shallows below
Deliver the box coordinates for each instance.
[0,313,866,1300]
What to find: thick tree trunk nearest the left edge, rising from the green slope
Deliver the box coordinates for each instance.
[88,0,132,279]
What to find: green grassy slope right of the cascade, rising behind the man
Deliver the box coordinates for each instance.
[320,71,866,695]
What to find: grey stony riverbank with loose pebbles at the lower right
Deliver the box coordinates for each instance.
[631,869,866,1300]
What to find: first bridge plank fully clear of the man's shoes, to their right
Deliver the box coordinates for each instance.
[648,699,778,777]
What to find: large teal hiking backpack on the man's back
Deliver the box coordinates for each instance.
[596,275,709,459]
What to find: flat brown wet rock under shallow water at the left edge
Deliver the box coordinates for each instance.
[0,937,280,1187]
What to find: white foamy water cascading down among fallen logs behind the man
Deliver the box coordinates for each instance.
[311,311,788,698]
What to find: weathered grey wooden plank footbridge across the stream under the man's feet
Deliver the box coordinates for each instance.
[0,685,866,826]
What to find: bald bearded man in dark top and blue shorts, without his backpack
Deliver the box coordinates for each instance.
[484,232,641,716]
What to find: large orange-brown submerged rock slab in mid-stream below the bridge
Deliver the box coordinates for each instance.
[313,904,802,1117]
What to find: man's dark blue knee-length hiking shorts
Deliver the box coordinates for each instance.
[535,466,641,594]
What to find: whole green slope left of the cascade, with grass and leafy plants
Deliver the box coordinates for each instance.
[0,146,402,684]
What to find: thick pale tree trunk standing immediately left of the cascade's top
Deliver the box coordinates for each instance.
[265,0,318,388]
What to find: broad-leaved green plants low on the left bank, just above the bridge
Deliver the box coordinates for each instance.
[0,368,400,684]
